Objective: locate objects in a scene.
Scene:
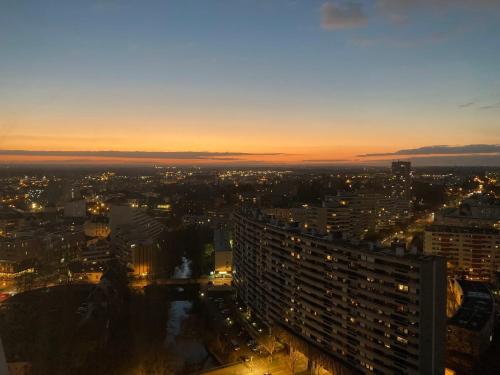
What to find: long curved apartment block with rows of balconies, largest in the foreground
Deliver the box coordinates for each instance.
[233,211,446,375]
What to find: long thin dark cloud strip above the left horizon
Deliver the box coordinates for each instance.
[0,150,284,161]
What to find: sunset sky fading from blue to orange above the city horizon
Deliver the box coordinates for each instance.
[0,0,500,165]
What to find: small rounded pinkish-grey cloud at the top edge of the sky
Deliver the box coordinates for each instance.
[321,1,368,30]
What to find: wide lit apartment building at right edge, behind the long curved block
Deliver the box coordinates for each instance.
[424,225,500,281]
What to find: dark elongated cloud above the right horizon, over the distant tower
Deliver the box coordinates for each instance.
[358,144,500,158]
